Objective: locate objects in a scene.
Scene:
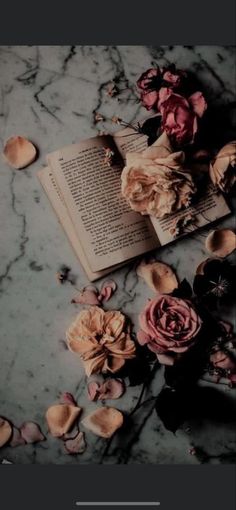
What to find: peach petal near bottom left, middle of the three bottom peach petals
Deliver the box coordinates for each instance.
[46,404,81,437]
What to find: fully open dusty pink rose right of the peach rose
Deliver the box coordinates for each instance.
[137,294,202,365]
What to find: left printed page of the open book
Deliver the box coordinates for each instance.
[48,136,159,272]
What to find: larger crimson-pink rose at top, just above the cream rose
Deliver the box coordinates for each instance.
[158,88,207,145]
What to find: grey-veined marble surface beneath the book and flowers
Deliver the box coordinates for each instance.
[0,46,235,464]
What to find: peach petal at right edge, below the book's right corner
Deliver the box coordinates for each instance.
[206,229,236,258]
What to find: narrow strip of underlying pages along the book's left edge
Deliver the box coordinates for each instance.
[38,167,125,281]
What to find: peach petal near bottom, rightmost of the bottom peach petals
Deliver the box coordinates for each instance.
[82,407,124,438]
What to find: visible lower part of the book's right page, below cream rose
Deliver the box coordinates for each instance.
[150,184,231,245]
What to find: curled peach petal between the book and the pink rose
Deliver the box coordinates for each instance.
[137,262,178,294]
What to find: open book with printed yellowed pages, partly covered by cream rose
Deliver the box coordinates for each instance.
[38,128,230,281]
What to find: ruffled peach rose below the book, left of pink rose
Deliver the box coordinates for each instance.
[66,306,135,376]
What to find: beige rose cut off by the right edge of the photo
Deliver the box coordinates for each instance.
[209,141,236,193]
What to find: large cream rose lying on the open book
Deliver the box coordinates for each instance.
[121,133,196,218]
